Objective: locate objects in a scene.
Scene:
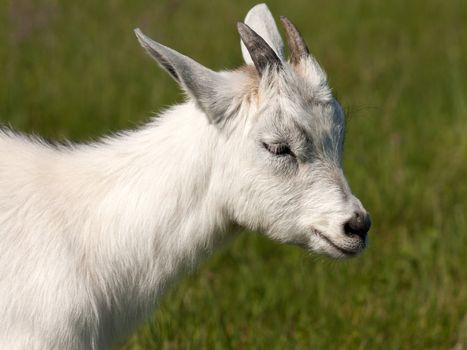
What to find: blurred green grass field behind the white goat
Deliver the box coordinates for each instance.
[0,0,467,350]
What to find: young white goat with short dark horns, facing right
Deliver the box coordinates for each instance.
[0,5,370,350]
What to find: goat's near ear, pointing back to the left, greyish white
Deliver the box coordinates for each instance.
[135,28,226,123]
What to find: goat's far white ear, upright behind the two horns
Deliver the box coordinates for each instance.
[240,4,285,64]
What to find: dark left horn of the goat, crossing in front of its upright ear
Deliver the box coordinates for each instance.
[237,22,282,76]
